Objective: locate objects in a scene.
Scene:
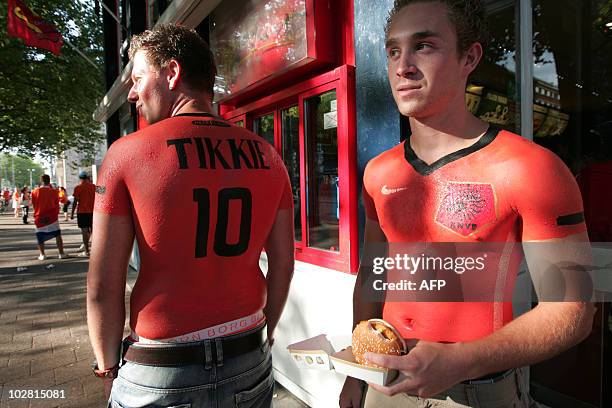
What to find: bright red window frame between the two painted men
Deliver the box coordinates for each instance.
[221,65,359,273]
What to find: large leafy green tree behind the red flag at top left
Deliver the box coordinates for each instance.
[0,0,104,163]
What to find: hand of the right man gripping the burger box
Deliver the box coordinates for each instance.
[366,341,469,398]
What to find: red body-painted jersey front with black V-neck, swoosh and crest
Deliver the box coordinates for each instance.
[363,128,586,342]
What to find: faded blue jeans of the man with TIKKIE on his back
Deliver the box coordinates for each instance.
[108,331,274,408]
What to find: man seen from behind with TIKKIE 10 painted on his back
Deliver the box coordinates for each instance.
[87,25,293,407]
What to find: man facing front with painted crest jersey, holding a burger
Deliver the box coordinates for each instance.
[340,0,593,408]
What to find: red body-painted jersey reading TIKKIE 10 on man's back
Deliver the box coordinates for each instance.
[95,115,293,339]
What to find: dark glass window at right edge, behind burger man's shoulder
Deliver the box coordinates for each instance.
[533,0,612,242]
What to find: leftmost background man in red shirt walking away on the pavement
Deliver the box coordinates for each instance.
[32,174,66,261]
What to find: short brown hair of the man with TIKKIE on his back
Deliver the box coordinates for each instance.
[129,24,217,95]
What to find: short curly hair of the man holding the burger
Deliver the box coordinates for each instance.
[385,0,488,55]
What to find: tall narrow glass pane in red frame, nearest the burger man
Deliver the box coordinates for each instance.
[304,90,340,251]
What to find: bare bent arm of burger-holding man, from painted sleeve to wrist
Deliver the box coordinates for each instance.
[463,233,594,378]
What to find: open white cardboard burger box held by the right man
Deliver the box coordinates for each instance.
[287,334,397,385]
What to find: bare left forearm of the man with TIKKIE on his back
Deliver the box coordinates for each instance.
[87,212,134,370]
